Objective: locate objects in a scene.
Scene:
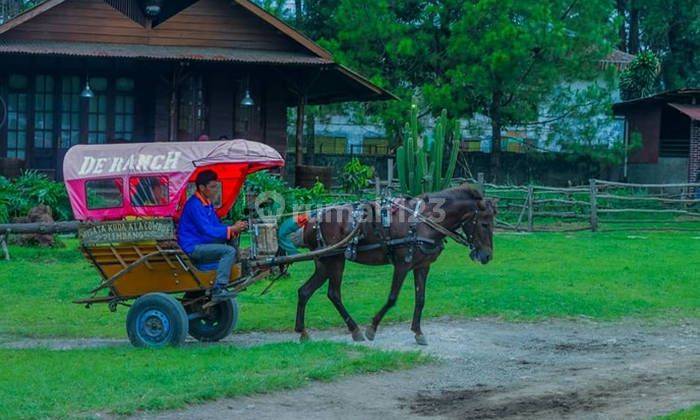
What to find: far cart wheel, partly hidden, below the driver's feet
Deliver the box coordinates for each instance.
[185,294,238,342]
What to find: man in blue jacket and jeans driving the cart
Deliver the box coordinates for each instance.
[177,170,248,300]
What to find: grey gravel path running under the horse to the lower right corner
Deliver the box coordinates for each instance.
[2,319,700,420]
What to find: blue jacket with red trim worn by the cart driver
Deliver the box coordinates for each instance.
[177,192,233,254]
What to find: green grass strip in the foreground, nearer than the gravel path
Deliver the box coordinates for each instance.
[0,342,429,418]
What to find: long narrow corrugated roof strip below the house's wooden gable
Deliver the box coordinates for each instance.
[0,40,333,65]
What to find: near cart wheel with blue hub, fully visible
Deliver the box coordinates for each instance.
[126,293,188,348]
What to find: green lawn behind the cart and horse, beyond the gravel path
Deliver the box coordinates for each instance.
[0,231,700,337]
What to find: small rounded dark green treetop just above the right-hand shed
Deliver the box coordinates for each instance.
[620,51,661,100]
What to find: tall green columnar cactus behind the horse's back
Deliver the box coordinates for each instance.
[396,104,461,196]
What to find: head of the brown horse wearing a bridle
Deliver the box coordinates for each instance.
[462,198,497,264]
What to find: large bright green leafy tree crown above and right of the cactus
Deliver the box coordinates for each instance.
[434,0,611,141]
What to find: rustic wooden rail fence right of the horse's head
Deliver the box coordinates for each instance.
[482,179,700,232]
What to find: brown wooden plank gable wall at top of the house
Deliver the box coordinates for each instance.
[0,0,302,54]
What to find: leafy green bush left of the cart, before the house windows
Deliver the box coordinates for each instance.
[0,171,73,223]
